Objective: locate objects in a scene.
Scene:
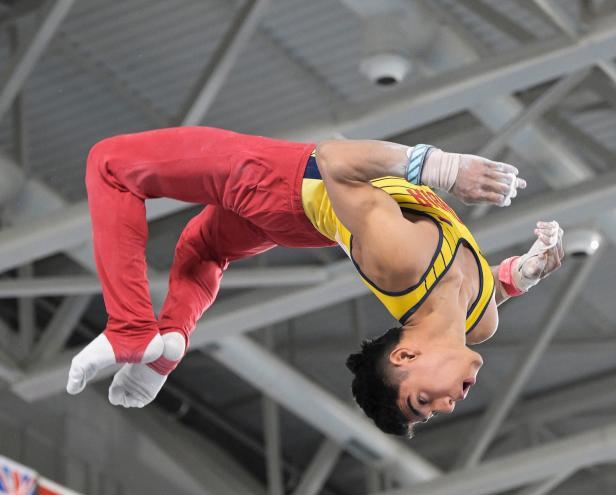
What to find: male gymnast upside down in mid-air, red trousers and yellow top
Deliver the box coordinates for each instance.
[67,127,564,435]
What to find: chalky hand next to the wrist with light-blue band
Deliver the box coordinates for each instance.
[450,155,526,206]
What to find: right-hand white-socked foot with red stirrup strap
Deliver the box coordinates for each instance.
[109,332,185,407]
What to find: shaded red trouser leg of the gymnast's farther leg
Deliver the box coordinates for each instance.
[148,206,276,375]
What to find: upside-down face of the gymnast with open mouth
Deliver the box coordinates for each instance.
[389,345,483,423]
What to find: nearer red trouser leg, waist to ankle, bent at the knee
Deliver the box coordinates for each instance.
[86,127,330,362]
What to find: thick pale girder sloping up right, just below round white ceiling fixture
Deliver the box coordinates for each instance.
[284,12,616,144]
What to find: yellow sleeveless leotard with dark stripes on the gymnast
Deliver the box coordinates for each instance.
[302,157,494,333]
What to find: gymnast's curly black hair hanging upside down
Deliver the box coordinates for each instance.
[346,327,412,437]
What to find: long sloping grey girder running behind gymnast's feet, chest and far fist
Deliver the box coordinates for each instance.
[14,172,616,400]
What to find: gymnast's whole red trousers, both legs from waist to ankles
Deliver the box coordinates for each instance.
[86,127,333,363]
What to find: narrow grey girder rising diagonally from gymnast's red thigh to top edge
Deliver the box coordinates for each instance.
[179,0,270,125]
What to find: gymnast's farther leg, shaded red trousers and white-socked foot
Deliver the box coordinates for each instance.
[109,206,275,407]
